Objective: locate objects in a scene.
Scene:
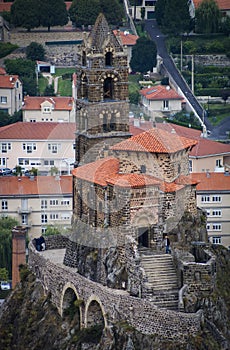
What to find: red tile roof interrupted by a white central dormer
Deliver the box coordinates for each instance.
[22,96,74,111]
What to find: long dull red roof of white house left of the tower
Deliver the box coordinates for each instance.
[0,122,76,140]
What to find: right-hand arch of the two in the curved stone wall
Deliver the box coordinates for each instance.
[85,295,107,330]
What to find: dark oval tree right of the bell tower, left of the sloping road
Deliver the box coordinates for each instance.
[130,37,157,73]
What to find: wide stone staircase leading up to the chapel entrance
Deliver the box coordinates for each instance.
[141,253,179,310]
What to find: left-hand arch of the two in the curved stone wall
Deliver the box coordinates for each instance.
[60,283,84,330]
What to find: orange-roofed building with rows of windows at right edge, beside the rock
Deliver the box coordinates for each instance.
[192,172,230,248]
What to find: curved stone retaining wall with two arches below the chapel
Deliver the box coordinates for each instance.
[29,238,202,343]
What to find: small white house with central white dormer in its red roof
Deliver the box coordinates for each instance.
[22,96,75,123]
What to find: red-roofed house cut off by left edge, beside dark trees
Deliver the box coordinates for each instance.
[0,71,22,115]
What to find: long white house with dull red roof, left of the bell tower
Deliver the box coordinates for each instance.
[0,122,76,174]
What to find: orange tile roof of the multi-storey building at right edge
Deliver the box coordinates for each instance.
[191,173,230,192]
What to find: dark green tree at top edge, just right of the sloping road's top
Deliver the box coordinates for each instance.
[156,0,191,35]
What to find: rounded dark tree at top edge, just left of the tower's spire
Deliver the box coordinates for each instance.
[69,0,101,27]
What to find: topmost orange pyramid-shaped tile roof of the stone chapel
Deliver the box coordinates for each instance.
[111,128,197,153]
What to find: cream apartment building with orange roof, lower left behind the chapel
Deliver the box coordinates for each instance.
[0,175,72,238]
